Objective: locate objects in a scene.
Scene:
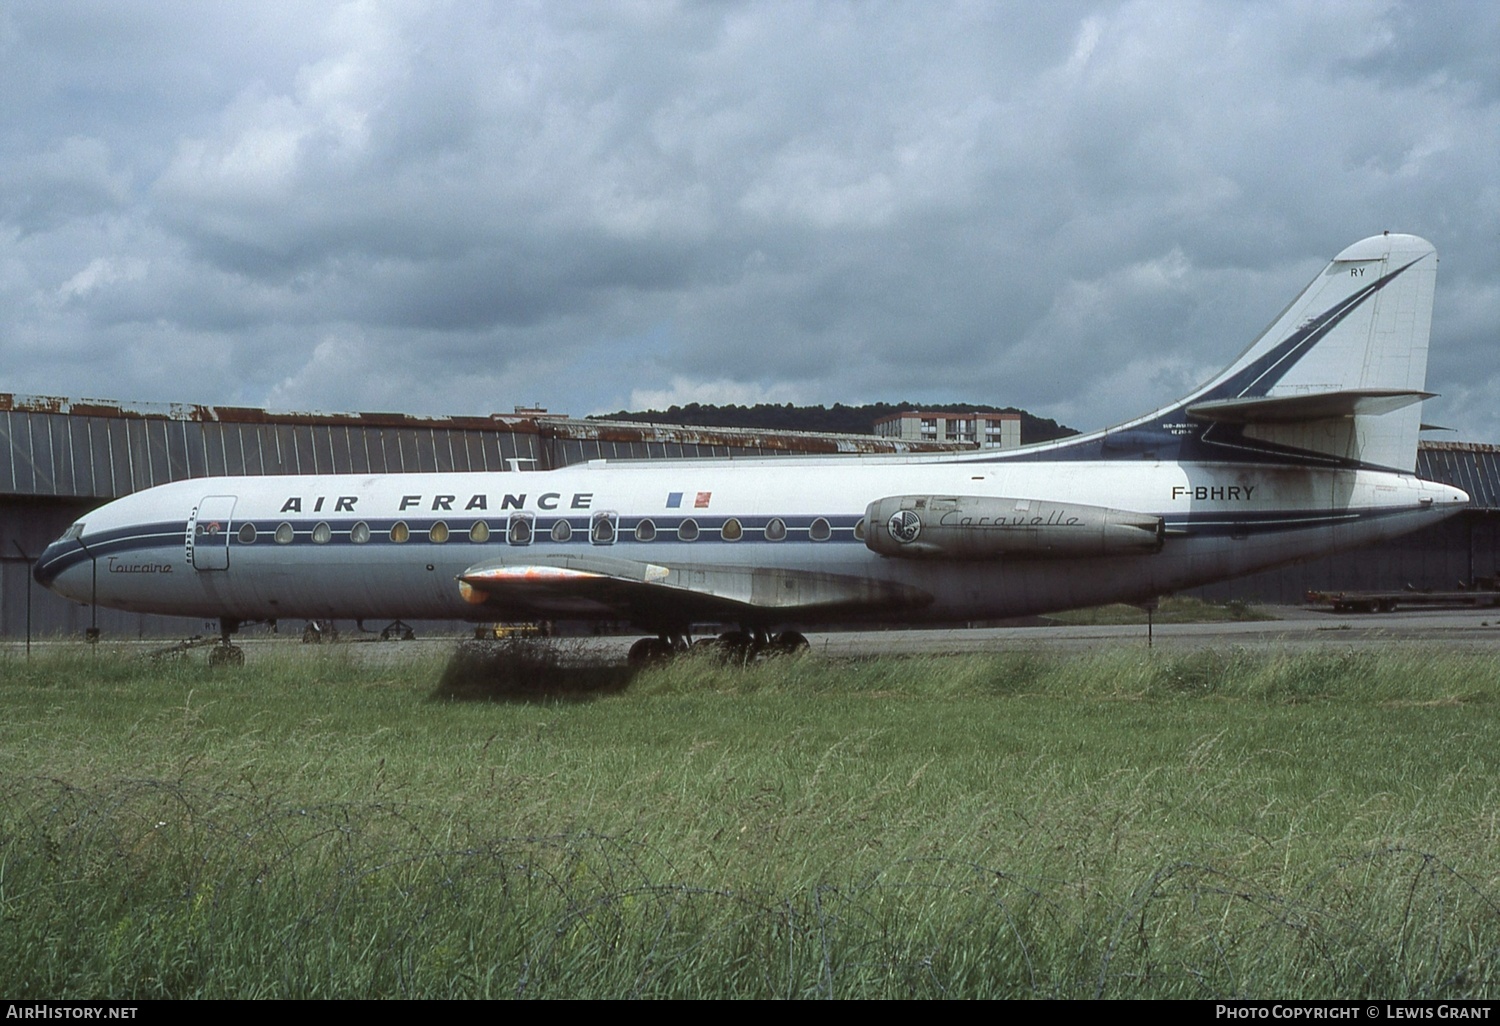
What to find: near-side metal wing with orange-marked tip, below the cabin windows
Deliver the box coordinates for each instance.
[459,555,933,630]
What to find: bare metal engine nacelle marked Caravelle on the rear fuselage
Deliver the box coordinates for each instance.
[864,495,1166,560]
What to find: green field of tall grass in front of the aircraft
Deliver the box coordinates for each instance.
[0,645,1500,999]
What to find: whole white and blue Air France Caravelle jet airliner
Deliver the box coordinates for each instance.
[35,233,1469,662]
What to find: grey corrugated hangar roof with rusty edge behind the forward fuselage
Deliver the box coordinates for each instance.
[0,393,954,498]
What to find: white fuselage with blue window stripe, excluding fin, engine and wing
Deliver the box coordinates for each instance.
[38,455,1469,624]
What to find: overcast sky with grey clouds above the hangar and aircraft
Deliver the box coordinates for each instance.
[0,0,1500,443]
